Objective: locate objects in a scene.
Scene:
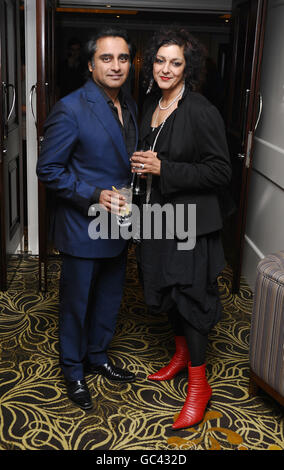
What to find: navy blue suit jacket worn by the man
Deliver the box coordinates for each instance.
[37,80,138,258]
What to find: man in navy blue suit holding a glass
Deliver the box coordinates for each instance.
[37,29,138,410]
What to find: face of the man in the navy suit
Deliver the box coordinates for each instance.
[88,36,130,89]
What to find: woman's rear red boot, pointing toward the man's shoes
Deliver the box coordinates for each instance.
[148,336,190,380]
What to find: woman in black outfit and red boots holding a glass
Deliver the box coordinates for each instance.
[131,30,231,429]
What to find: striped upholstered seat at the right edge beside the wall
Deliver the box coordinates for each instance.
[249,251,284,396]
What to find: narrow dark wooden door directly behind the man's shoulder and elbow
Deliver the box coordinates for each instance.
[36,0,56,290]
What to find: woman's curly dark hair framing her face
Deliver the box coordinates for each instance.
[142,28,206,92]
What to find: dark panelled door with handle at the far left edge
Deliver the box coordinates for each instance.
[0,0,24,290]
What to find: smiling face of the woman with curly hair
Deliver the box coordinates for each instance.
[153,44,186,91]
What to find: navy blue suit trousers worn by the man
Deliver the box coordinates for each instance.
[59,249,127,380]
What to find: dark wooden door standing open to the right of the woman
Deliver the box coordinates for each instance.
[224,0,267,292]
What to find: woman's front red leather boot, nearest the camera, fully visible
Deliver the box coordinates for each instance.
[172,364,212,429]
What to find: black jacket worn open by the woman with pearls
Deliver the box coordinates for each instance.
[140,90,232,236]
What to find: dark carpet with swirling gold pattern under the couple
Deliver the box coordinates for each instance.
[0,246,284,451]
